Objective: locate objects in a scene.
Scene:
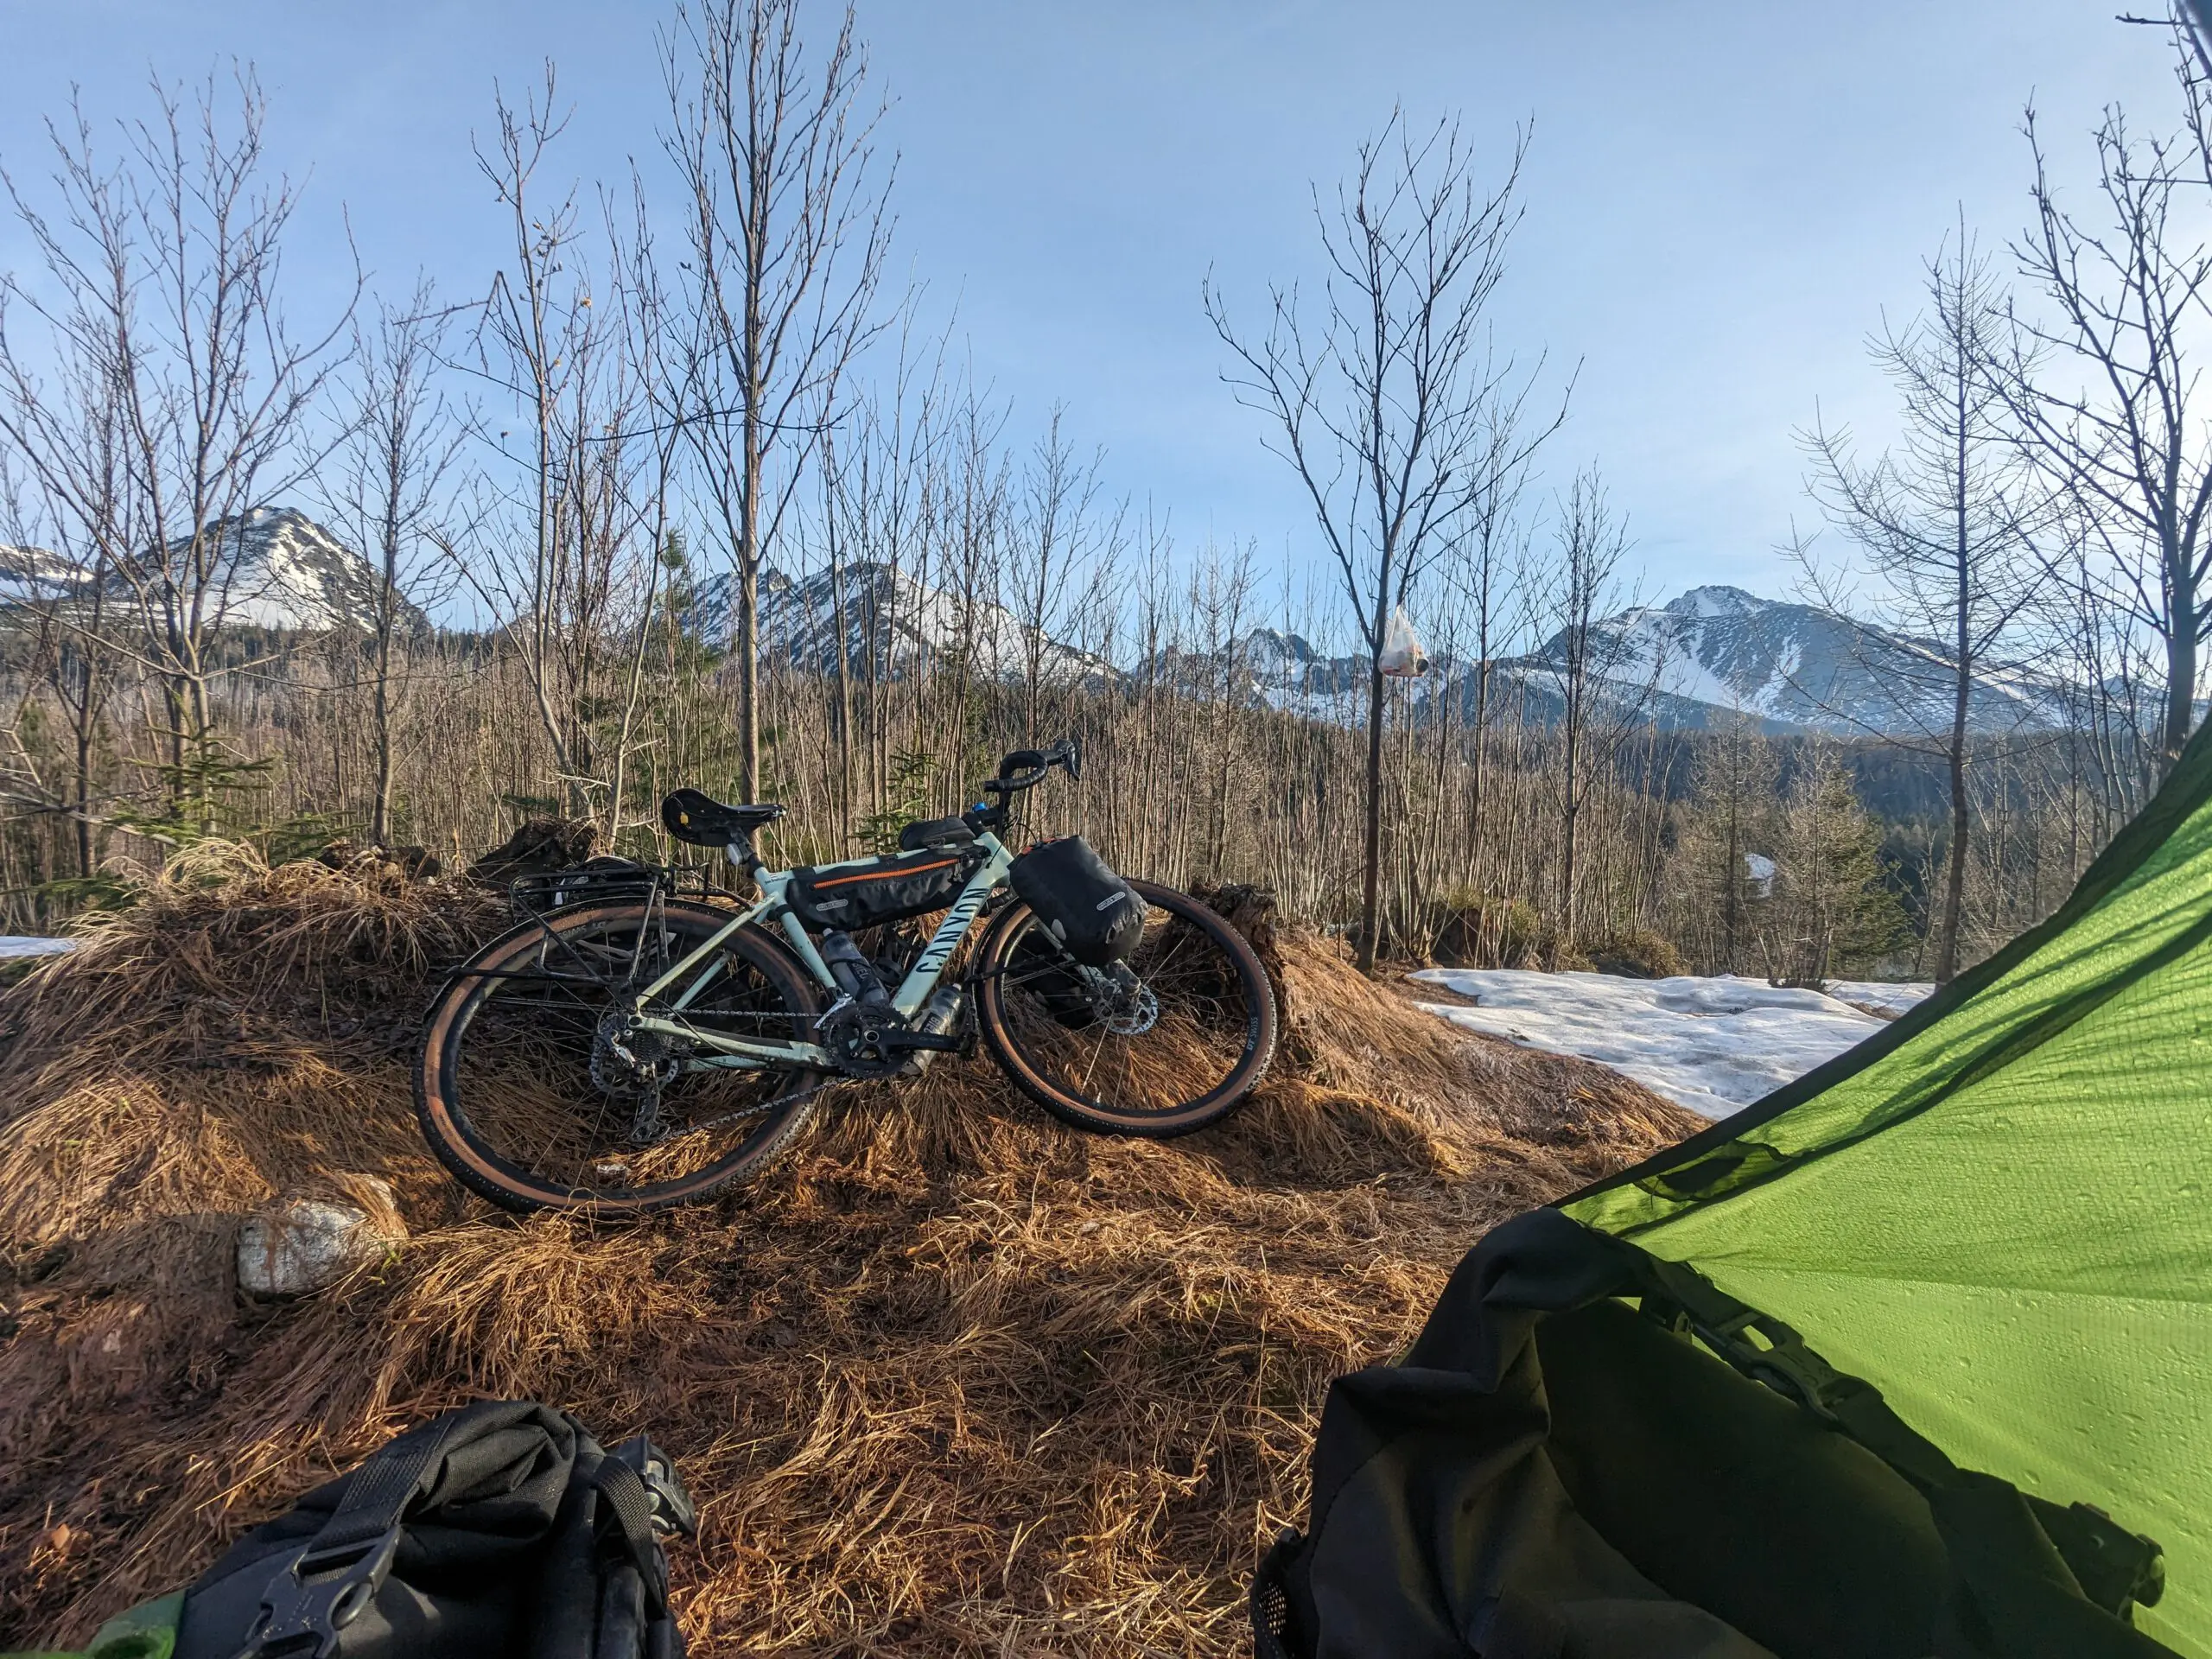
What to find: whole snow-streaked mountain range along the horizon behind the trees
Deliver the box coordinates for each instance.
[0,506,2069,736]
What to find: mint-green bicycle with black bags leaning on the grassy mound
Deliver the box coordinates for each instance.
[416,741,1276,1214]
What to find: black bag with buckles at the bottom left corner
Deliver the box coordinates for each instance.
[175,1400,695,1659]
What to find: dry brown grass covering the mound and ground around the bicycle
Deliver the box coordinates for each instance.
[0,854,1690,1655]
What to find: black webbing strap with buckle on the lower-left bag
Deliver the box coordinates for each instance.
[234,1414,454,1659]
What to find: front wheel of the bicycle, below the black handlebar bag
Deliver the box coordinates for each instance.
[976,880,1276,1139]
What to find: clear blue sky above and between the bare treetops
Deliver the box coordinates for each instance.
[0,0,2174,610]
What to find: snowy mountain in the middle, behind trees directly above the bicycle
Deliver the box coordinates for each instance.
[683,564,1115,683]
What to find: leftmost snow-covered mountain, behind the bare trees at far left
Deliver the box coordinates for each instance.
[0,506,427,632]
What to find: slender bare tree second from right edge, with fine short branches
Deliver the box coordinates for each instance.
[1805,226,2042,982]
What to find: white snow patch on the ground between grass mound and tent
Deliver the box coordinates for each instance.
[1411,969,1893,1117]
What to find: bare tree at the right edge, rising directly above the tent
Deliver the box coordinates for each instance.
[2011,34,2212,766]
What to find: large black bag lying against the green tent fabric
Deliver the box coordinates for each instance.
[1252,1210,2168,1659]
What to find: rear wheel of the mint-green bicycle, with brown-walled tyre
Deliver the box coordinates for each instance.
[416,900,823,1214]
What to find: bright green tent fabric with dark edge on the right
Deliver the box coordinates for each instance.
[1561,732,2212,1659]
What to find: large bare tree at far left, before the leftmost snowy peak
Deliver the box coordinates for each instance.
[0,68,359,834]
